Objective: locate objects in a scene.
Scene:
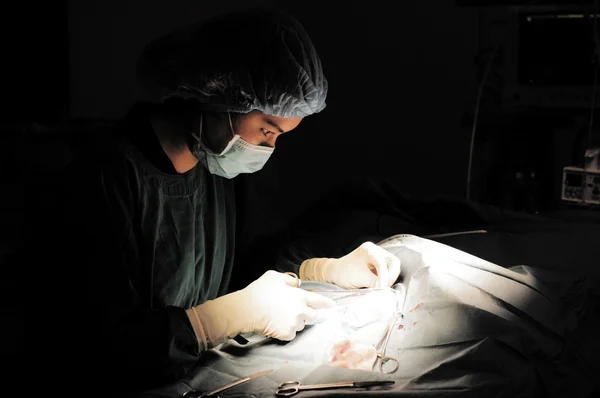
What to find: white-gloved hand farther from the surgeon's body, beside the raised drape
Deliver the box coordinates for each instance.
[300,242,400,289]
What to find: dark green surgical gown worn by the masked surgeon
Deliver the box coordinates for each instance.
[57,104,236,390]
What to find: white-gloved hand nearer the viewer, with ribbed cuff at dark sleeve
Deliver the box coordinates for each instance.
[186,271,336,349]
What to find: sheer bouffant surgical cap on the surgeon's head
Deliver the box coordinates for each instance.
[137,9,327,118]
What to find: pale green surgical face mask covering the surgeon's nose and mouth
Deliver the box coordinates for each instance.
[192,112,274,178]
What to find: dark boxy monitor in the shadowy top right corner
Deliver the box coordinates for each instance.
[501,4,600,109]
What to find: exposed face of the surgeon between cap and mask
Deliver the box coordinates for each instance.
[203,111,302,153]
